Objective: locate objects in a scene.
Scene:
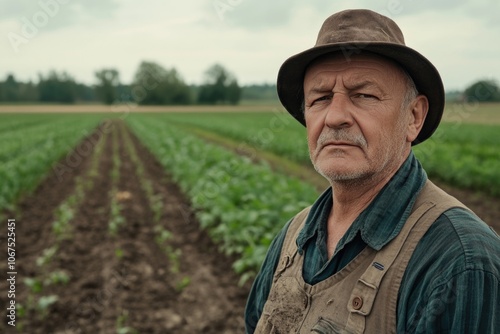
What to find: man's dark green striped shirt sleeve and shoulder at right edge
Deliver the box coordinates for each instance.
[398,207,500,333]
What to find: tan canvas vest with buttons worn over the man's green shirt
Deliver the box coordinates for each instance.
[255,181,465,334]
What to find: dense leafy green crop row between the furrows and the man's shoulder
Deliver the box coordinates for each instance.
[127,115,318,280]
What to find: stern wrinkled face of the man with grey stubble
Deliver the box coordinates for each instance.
[304,55,411,183]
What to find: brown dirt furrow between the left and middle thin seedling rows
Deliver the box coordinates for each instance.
[40,126,113,333]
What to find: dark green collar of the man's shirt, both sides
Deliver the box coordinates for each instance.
[297,152,427,254]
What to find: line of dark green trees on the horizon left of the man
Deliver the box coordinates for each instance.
[0,61,276,105]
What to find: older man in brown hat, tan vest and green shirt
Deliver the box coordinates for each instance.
[245,10,500,333]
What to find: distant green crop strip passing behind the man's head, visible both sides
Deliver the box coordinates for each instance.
[151,112,500,197]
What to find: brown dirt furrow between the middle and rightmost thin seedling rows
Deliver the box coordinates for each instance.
[95,123,180,333]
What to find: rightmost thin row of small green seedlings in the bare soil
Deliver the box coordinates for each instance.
[124,131,191,292]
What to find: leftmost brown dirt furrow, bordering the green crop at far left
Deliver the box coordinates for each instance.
[0,125,111,333]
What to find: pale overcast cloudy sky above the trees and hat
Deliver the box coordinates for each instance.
[0,0,500,90]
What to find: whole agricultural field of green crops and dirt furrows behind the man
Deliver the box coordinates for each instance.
[0,105,500,333]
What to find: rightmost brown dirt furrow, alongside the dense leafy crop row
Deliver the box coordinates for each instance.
[127,121,249,334]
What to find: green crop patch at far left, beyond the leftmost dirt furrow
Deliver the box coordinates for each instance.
[0,114,101,211]
